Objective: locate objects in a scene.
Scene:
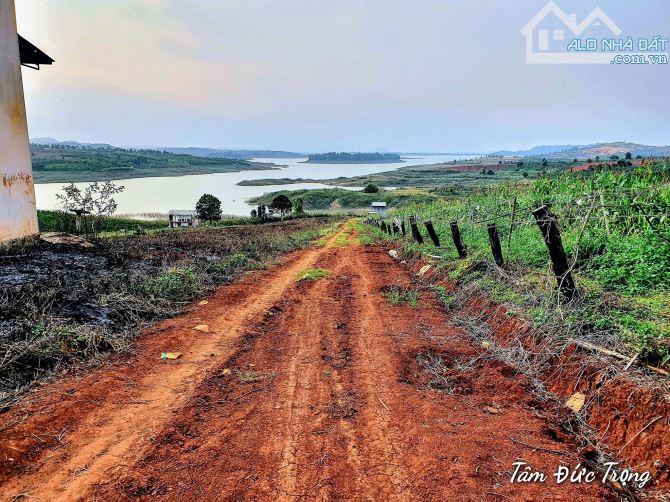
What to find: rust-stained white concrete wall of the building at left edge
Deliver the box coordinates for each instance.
[0,0,37,241]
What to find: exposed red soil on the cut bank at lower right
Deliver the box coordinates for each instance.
[448,294,670,490]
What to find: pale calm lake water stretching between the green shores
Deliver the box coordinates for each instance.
[35,155,470,216]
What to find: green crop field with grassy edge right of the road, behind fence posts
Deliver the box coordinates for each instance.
[362,161,670,365]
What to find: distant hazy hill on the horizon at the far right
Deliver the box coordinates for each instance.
[494,141,670,159]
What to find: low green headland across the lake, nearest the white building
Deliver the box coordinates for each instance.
[30,145,273,183]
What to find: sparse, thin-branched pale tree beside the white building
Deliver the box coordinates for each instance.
[56,181,124,234]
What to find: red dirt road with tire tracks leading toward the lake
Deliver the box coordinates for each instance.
[0,226,608,501]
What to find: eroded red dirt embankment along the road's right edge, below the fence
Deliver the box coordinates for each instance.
[404,260,670,494]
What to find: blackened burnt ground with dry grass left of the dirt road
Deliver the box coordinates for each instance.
[0,218,331,403]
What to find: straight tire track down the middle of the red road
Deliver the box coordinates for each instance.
[279,251,358,499]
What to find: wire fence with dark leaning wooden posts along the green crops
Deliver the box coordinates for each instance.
[366,182,670,298]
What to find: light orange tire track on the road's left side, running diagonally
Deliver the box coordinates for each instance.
[0,229,352,500]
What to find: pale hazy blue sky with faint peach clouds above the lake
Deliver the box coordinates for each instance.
[16,0,670,152]
